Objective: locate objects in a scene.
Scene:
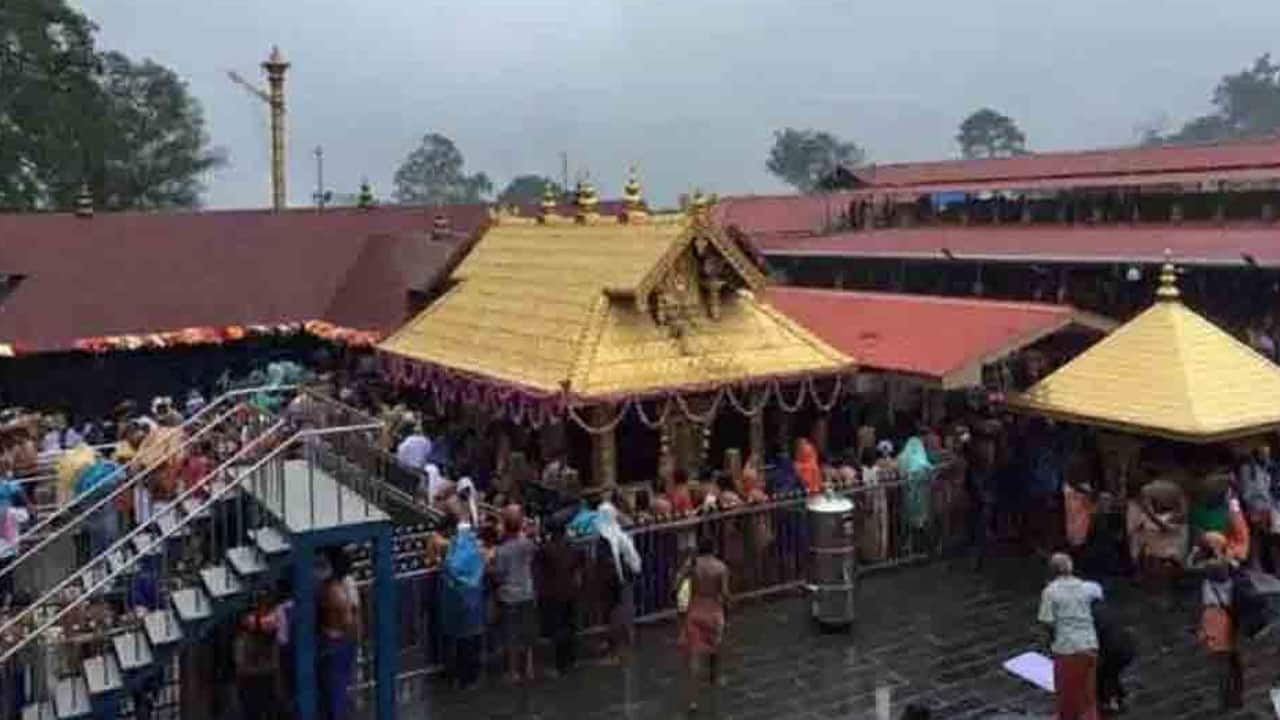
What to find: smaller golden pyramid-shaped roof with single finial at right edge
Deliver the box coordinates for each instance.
[1009,264,1280,443]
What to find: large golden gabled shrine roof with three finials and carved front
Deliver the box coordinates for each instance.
[379,196,852,401]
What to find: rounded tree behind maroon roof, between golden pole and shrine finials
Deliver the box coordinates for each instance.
[394,132,493,205]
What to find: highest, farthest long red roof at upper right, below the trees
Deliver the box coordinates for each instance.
[854,138,1280,188]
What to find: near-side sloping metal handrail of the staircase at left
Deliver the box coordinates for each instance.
[0,420,291,664]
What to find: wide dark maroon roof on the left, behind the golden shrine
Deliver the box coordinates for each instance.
[0,205,486,352]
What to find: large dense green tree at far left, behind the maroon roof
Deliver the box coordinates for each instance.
[0,0,223,210]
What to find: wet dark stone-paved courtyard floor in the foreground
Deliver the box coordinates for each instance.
[401,559,1280,720]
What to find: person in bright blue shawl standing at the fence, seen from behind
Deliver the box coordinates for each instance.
[440,515,485,688]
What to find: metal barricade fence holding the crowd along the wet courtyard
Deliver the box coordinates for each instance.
[345,465,969,681]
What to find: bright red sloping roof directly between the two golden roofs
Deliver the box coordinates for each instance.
[767,286,1111,388]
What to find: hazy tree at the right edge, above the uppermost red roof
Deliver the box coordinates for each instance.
[1158,55,1280,143]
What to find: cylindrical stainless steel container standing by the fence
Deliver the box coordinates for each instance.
[806,491,856,625]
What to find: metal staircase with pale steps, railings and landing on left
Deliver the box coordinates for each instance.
[0,393,388,720]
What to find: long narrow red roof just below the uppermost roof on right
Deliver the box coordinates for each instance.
[755,223,1280,266]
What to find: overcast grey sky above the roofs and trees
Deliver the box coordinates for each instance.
[73,0,1280,208]
